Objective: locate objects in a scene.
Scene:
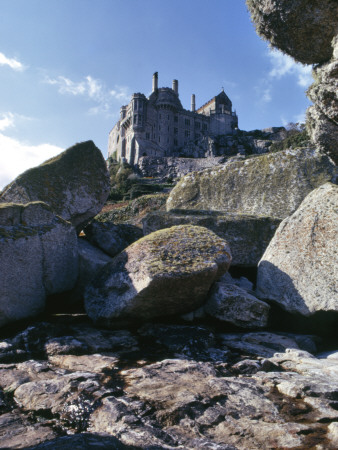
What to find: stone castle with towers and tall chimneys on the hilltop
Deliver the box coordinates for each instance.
[108,72,238,165]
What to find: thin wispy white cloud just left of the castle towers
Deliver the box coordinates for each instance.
[45,75,131,114]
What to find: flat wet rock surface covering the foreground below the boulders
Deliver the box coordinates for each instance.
[0,316,338,450]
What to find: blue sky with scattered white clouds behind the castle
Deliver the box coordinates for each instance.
[0,0,312,188]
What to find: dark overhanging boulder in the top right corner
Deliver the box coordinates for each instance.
[246,0,338,64]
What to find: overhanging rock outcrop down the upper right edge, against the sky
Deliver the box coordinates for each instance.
[246,0,338,163]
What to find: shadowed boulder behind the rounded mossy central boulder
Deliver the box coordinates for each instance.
[142,211,281,267]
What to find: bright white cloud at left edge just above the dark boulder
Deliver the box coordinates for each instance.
[0,133,64,190]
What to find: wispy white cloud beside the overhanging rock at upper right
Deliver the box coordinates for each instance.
[269,50,313,88]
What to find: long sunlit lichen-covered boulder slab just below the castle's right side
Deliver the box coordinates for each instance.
[167,148,336,219]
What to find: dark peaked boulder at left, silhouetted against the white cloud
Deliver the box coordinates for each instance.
[0,141,109,229]
